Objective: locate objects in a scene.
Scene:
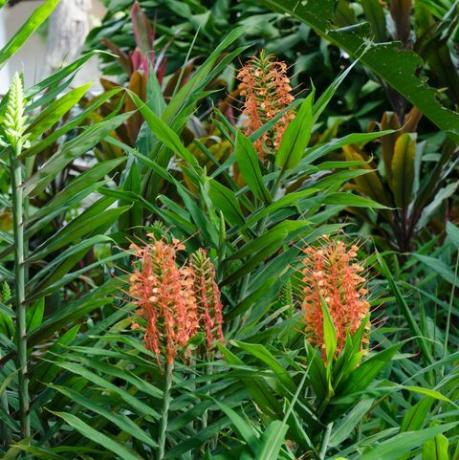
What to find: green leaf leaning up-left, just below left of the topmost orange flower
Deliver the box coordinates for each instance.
[234,131,272,203]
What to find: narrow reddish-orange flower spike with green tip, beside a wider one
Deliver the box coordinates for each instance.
[191,249,223,349]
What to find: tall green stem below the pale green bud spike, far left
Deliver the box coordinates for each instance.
[10,148,30,438]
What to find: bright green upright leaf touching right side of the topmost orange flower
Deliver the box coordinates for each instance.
[276,90,314,170]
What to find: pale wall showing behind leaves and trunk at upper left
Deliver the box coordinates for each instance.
[0,0,104,94]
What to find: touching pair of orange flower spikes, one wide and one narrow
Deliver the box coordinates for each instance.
[129,235,223,364]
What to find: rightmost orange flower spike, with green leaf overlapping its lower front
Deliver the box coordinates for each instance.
[302,237,370,352]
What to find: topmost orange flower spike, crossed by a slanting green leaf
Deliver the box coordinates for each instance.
[238,52,295,159]
